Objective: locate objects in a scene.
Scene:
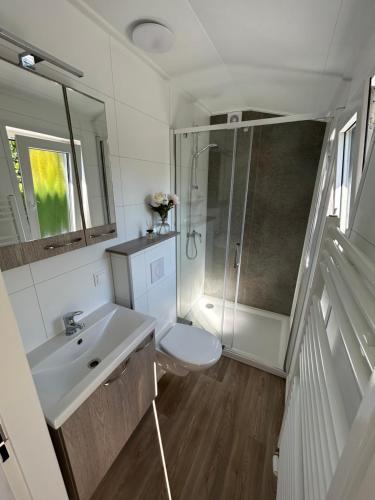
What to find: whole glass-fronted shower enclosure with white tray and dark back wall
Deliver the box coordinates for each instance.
[175,112,325,373]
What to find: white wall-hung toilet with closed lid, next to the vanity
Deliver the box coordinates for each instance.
[156,323,222,376]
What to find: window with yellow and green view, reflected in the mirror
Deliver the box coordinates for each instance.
[6,126,80,239]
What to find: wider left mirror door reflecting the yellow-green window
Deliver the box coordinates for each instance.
[0,61,83,246]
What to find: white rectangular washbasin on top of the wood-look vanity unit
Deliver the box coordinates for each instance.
[28,304,156,429]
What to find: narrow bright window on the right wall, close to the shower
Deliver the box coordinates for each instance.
[328,114,357,232]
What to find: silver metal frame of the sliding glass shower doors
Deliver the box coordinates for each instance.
[173,111,334,377]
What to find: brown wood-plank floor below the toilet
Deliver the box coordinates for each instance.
[93,358,285,500]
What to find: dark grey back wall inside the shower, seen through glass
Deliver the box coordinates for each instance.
[205,111,325,315]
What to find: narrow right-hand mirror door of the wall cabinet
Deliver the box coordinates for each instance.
[67,88,115,228]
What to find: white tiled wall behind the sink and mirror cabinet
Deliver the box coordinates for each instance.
[0,0,210,351]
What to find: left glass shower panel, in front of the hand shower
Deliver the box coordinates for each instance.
[175,130,236,339]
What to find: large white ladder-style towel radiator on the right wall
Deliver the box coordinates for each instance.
[277,218,375,500]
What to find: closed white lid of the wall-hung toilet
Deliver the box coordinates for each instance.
[160,323,221,365]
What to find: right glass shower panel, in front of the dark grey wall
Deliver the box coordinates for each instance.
[229,121,324,372]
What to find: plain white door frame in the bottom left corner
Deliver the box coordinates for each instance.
[0,270,68,500]
